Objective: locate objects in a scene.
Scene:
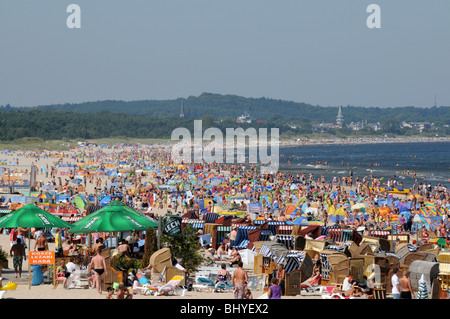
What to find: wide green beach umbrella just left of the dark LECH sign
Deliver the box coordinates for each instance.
[69,200,158,233]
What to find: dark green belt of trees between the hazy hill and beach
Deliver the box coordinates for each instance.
[0,108,450,141]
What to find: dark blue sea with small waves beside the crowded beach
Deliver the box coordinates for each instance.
[280,142,450,187]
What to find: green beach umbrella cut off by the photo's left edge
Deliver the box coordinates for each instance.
[0,204,72,228]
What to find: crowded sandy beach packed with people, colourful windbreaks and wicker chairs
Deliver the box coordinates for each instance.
[0,143,450,299]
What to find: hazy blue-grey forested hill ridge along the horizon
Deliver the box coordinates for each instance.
[4,93,450,126]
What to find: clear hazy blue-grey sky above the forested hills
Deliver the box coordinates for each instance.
[0,0,450,107]
